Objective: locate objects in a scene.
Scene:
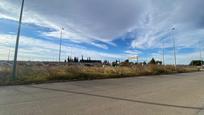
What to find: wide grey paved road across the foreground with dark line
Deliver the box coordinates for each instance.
[0,72,204,115]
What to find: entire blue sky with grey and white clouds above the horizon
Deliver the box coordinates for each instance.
[0,0,204,64]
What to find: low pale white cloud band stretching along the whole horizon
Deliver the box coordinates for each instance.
[0,34,204,64]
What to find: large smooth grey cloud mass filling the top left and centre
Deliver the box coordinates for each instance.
[0,0,147,42]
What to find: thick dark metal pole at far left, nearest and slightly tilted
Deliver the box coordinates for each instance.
[12,0,24,80]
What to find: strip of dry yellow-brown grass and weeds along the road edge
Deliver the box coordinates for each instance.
[0,64,197,85]
